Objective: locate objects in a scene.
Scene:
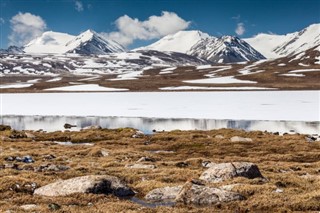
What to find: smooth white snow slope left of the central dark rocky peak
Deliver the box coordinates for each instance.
[135,30,210,53]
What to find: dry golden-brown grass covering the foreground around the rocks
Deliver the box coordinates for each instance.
[0,129,320,212]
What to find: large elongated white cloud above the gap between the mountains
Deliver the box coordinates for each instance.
[102,11,191,46]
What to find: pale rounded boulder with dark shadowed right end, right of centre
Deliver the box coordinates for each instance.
[200,162,263,182]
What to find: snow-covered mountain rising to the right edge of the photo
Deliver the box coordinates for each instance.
[244,24,320,58]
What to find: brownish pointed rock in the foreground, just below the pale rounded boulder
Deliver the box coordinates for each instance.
[176,182,245,206]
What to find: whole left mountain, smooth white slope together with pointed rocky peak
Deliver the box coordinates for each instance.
[23,30,125,55]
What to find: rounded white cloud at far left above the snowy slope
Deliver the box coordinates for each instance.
[8,12,47,46]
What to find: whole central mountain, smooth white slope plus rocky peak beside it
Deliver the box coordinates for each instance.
[138,31,264,63]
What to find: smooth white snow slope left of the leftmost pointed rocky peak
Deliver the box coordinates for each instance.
[24,31,75,54]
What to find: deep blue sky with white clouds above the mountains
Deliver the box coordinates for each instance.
[0,0,320,48]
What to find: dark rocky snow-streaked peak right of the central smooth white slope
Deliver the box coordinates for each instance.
[187,36,265,63]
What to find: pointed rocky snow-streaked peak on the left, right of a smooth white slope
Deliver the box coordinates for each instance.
[66,30,125,55]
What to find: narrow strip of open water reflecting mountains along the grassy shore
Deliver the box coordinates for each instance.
[0,115,320,134]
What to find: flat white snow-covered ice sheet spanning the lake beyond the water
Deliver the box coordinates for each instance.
[0,91,320,121]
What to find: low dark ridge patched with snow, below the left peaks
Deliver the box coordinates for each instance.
[0,50,208,76]
